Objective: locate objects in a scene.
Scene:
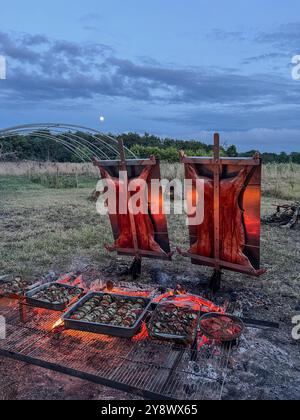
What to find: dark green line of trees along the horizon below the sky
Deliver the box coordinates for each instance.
[0,131,300,164]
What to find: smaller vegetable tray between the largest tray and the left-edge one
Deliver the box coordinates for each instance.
[25,283,84,312]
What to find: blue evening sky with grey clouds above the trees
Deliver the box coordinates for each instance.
[0,0,300,152]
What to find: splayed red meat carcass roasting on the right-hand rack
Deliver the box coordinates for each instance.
[187,164,253,269]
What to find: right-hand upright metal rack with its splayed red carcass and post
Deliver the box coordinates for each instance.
[178,134,266,291]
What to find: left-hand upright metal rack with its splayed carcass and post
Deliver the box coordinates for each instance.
[94,140,172,279]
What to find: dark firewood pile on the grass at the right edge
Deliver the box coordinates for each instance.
[264,202,300,229]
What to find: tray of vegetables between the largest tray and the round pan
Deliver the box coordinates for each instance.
[147,297,201,344]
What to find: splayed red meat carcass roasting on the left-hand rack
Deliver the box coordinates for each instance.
[96,162,165,254]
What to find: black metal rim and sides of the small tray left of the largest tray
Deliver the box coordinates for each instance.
[25,283,84,312]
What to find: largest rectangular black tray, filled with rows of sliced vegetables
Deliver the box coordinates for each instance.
[62,292,151,338]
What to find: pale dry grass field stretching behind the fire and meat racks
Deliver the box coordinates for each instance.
[0,164,300,302]
